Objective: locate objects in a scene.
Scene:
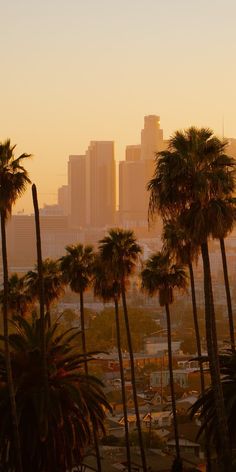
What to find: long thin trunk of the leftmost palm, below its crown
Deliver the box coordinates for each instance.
[1,210,23,472]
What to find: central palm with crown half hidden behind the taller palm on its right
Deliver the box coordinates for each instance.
[93,256,131,472]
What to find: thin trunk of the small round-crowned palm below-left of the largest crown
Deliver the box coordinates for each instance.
[165,304,181,463]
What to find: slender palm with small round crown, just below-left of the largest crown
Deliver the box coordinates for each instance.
[141,252,187,463]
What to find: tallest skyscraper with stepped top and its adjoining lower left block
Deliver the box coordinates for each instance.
[119,115,167,229]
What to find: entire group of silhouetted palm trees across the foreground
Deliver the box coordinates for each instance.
[0,128,236,472]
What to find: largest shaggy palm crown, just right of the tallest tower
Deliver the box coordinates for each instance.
[148,127,235,224]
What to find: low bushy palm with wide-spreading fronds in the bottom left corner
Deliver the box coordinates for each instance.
[0,317,110,472]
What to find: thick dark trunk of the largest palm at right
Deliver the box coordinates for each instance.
[201,241,232,472]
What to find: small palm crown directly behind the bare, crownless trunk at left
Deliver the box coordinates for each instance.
[25,258,64,326]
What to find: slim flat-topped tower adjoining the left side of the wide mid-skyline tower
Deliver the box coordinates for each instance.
[68,155,86,228]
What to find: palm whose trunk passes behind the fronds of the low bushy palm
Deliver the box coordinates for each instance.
[60,244,101,472]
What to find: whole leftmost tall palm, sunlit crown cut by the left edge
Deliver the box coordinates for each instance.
[0,139,30,472]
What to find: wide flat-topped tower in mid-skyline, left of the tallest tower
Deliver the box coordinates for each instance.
[85,141,116,228]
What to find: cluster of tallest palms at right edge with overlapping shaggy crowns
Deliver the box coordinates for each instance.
[148,127,236,472]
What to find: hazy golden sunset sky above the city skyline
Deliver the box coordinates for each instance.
[0,0,236,210]
